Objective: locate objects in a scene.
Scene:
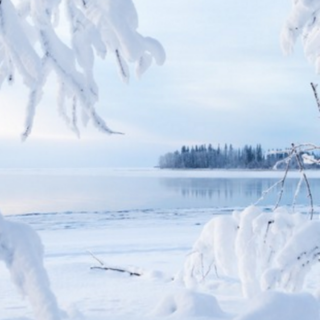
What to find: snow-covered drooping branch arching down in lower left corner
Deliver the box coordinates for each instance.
[0,214,61,320]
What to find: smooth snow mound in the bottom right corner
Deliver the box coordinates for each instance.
[234,291,320,320]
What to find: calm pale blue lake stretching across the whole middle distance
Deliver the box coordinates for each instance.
[0,169,320,214]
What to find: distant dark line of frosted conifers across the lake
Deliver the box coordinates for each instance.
[159,144,319,169]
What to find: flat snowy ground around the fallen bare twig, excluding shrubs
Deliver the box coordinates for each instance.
[0,208,320,320]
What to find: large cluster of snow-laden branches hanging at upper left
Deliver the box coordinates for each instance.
[0,0,165,139]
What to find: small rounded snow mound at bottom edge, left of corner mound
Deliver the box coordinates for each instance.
[153,291,228,319]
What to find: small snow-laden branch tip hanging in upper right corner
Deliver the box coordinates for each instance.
[281,0,320,73]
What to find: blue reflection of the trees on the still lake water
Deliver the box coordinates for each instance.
[161,178,320,206]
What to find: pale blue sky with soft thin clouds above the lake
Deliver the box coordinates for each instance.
[0,0,320,167]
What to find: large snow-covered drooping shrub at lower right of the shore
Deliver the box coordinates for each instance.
[179,206,320,297]
